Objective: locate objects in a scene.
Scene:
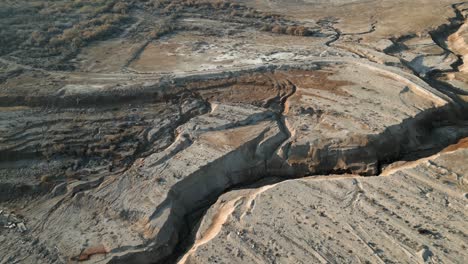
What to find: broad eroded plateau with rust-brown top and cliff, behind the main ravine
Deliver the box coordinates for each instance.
[2,60,468,263]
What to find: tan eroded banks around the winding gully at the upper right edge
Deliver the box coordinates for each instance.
[377,3,468,107]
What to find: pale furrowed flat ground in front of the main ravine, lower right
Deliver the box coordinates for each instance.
[178,139,468,263]
